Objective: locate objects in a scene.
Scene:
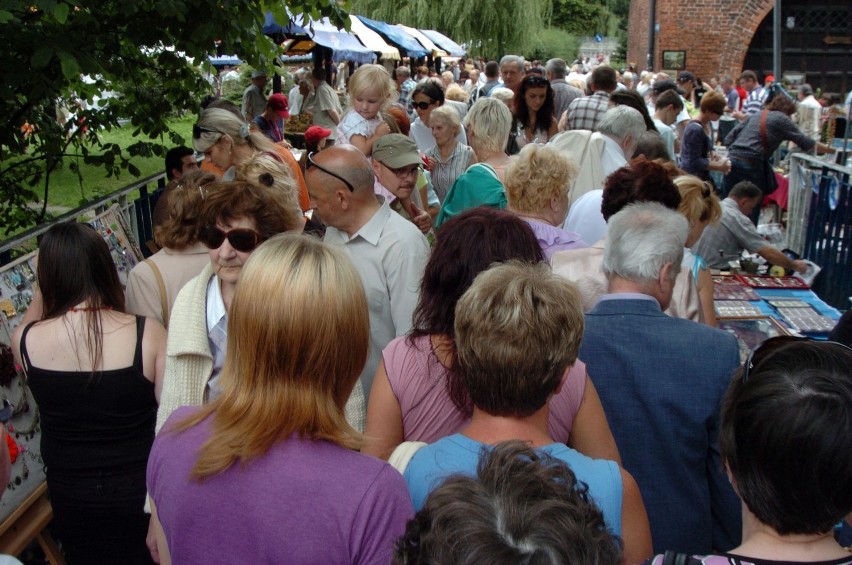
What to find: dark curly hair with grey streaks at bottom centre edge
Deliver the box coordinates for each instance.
[393,441,622,565]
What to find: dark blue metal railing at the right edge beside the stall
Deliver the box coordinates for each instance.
[787,153,852,310]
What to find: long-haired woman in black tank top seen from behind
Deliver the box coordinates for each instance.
[13,223,165,564]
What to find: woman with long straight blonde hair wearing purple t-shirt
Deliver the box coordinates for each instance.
[148,235,413,563]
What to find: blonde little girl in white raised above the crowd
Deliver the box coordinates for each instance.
[337,65,396,157]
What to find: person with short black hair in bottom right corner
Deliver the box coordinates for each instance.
[651,336,852,565]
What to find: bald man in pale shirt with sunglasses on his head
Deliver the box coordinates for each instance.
[305,145,429,398]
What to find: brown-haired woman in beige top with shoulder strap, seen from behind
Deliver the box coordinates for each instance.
[125,171,218,328]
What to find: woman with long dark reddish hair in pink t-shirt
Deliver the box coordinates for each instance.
[363,207,621,463]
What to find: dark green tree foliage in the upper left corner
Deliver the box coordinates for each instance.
[0,0,345,229]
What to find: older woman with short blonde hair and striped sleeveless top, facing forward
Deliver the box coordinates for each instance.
[426,106,476,202]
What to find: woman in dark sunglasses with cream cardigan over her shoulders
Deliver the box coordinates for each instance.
[157,181,310,431]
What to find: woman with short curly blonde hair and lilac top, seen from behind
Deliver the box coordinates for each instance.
[506,143,588,261]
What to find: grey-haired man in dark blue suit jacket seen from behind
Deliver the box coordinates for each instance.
[580,203,741,554]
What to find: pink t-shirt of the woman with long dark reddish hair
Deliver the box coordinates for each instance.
[382,336,586,443]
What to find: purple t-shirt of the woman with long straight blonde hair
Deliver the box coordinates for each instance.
[147,407,413,564]
